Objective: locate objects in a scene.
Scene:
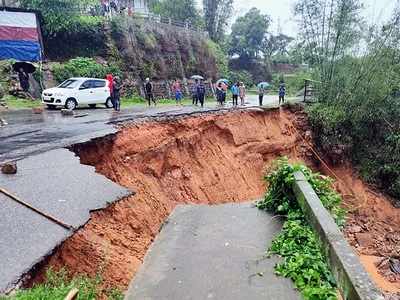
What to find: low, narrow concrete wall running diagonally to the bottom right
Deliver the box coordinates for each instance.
[293,172,384,300]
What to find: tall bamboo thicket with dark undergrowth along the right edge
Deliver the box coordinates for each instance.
[296,0,400,203]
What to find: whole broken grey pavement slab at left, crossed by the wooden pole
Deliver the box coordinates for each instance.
[0,149,132,293]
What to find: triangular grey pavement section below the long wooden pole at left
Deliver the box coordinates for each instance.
[0,194,71,294]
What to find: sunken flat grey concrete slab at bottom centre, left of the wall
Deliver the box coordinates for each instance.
[125,203,300,300]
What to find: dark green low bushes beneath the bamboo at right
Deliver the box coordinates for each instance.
[307,97,400,203]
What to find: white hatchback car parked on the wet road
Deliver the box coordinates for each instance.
[42,78,113,110]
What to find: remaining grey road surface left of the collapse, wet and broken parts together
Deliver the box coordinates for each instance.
[0,103,282,292]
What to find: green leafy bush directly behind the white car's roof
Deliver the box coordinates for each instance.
[53,57,121,82]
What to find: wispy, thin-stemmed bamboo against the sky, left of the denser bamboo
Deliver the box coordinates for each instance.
[295,0,365,82]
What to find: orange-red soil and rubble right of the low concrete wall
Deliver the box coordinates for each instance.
[334,164,400,299]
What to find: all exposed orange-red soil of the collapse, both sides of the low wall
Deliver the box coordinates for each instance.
[30,106,400,299]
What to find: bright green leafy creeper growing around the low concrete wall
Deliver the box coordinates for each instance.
[257,158,344,300]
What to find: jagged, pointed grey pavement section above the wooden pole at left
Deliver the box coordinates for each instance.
[0,149,131,228]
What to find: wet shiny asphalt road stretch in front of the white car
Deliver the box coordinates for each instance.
[0,95,296,163]
